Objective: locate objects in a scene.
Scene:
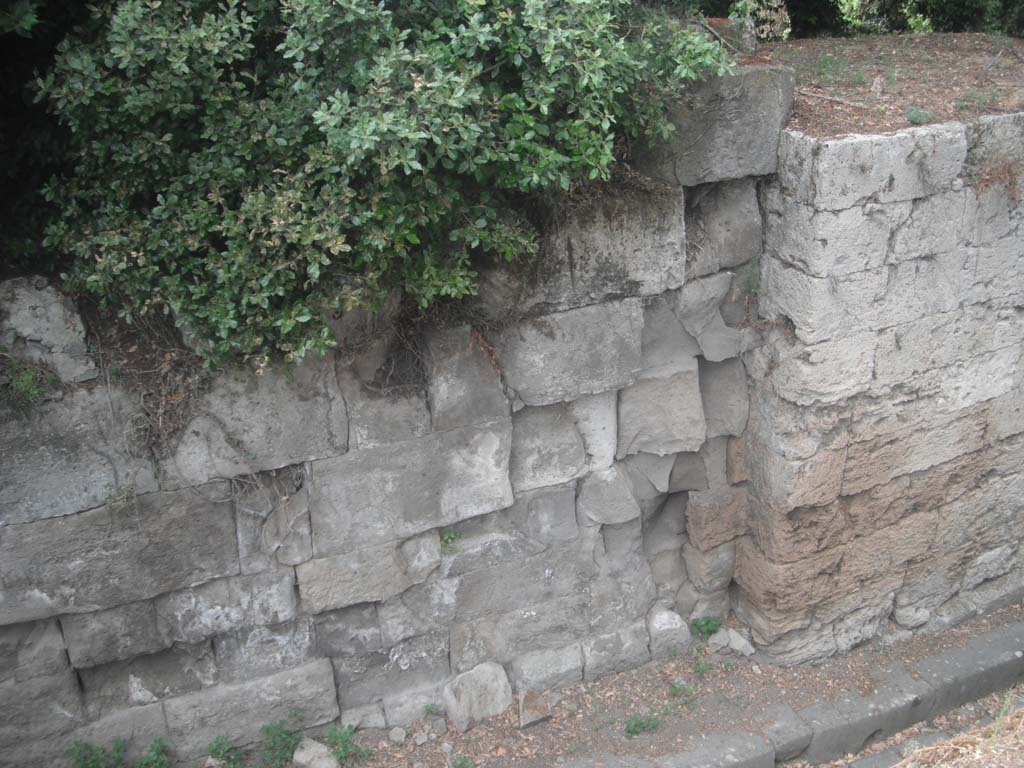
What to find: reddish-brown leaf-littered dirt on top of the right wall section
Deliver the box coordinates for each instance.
[740,34,1024,138]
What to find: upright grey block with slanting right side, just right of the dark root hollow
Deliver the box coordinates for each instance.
[426,326,509,430]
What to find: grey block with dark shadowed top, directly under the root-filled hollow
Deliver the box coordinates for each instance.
[334,333,430,455]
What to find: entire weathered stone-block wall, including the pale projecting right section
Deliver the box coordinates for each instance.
[0,67,1024,767]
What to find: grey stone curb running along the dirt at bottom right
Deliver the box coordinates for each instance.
[565,622,1024,768]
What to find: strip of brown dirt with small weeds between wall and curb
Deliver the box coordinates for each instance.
[335,606,1024,768]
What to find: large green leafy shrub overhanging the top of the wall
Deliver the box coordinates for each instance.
[40,0,727,360]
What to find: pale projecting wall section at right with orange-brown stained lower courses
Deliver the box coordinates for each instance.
[735,115,1024,662]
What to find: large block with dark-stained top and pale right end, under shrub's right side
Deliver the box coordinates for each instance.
[479,184,686,316]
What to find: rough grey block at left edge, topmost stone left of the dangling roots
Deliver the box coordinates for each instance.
[0,278,96,384]
